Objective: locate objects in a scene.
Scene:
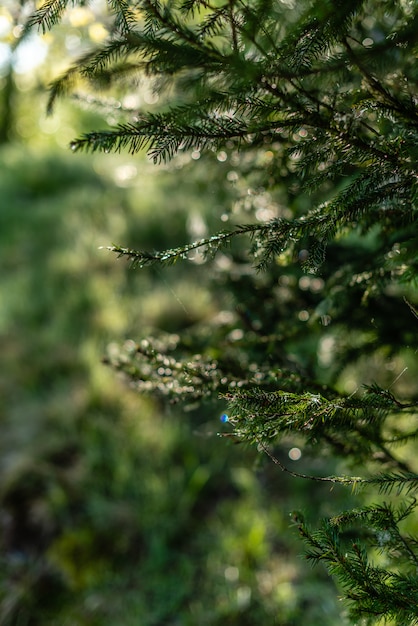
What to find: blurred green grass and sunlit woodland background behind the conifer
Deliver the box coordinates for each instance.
[0,0,378,626]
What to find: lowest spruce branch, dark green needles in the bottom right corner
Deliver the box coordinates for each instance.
[295,499,418,625]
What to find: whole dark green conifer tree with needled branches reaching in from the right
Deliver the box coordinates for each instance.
[28,0,418,626]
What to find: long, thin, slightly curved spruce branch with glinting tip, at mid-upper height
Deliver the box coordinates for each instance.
[102,173,415,270]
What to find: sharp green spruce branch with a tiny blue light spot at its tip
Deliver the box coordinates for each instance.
[223,387,411,475]
